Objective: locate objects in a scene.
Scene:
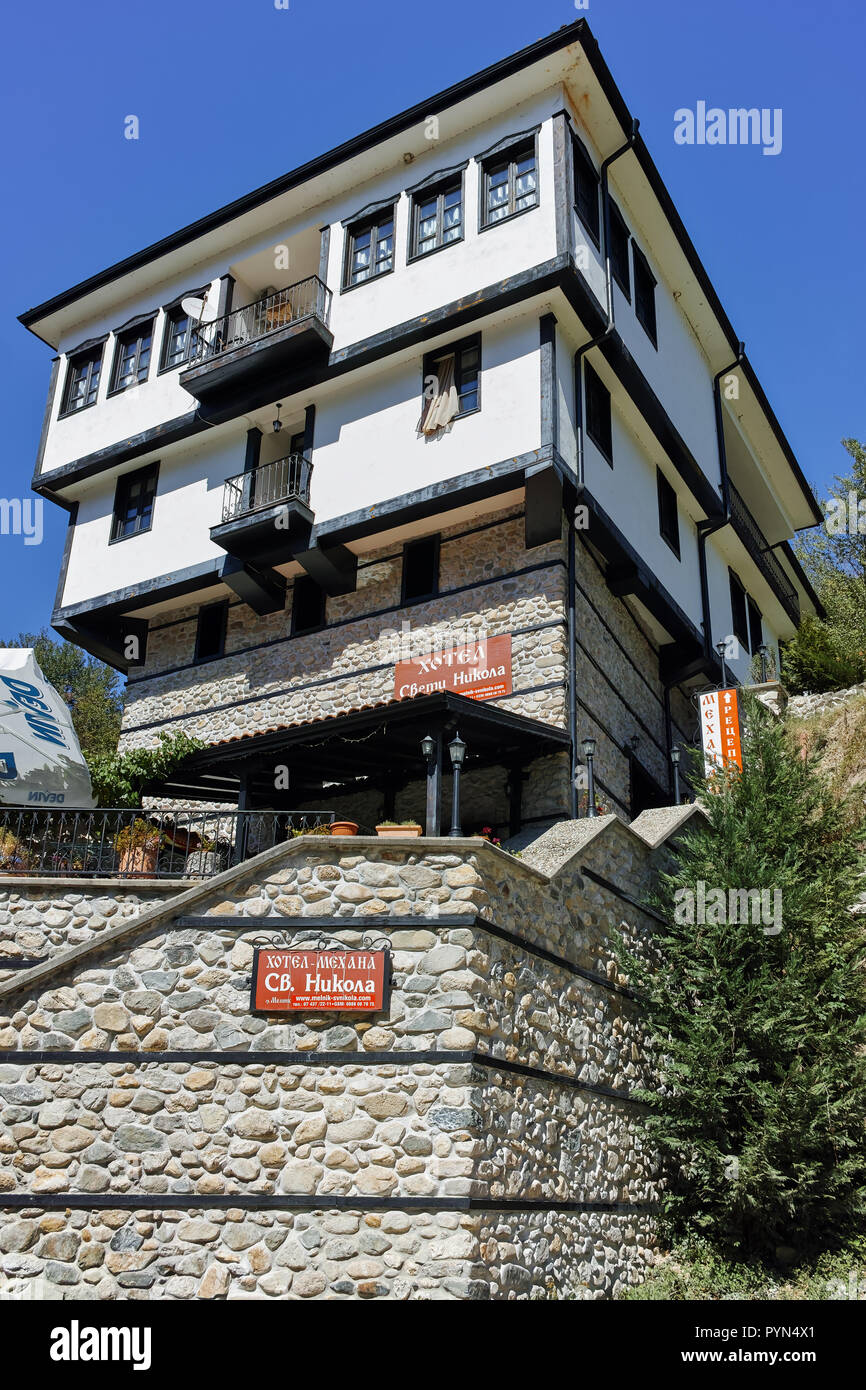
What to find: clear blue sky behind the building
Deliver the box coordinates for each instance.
[0,0,866,642]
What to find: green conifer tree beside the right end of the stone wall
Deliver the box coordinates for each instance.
[620,699,866,1258]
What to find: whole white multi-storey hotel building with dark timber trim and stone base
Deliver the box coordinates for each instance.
[22,19,822,831]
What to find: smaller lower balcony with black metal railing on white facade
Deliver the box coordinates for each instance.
[210,453,313,566]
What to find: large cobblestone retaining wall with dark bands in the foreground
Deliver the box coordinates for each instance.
[0,826,670,1298]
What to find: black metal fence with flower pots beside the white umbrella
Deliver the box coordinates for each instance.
[0,806,334,878]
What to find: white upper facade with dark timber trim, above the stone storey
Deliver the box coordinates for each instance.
[22,21,820,689]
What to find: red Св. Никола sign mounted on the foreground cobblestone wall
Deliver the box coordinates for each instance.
[252,947,388,1013]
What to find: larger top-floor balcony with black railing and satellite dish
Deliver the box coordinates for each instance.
[181,275,334,409]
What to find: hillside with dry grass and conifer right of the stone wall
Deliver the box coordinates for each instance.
[623,688,866,1301]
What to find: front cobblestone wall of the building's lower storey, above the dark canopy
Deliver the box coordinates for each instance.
[121,512,567,748]
